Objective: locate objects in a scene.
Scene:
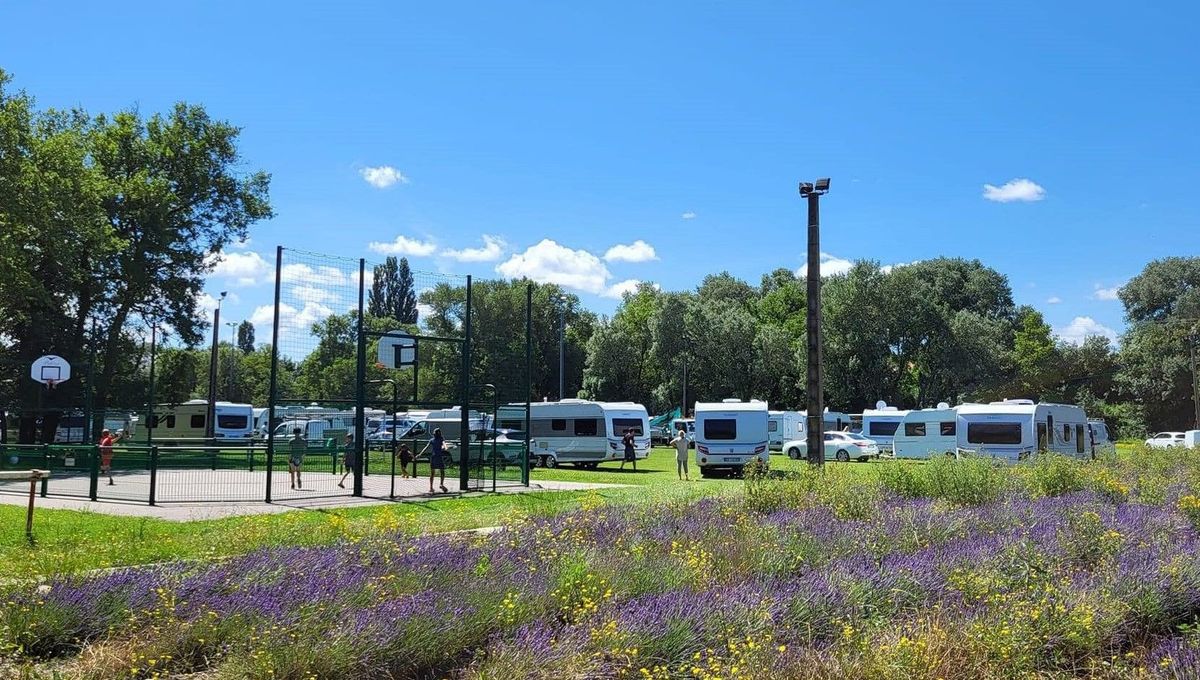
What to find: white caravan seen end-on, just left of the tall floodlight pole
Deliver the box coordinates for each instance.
[695,399,770,477]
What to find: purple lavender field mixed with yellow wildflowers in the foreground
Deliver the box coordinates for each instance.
[0,450,1200,679]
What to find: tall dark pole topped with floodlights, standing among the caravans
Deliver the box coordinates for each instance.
[800,177,829,467]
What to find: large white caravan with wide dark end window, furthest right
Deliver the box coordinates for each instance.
[958,399,1092,462]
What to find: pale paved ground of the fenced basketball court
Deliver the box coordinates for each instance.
[0,470,622,522]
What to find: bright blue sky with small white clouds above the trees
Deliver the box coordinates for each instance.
[0,1,1200,347]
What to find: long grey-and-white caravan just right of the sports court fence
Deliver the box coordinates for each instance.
[498,399,650,468]
